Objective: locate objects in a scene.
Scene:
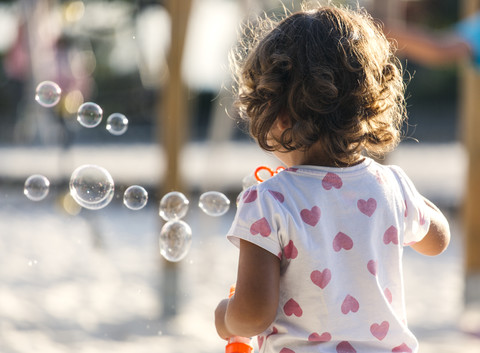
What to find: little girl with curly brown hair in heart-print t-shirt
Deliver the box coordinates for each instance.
[215,6,450,353]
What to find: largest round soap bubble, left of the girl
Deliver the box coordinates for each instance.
[70,164,115,210]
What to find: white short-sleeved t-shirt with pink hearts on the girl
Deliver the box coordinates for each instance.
[228,158,430,353]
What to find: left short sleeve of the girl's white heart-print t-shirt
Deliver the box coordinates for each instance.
[227,185,282,256]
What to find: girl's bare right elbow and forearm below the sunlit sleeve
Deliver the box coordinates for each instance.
[412,199,450,256]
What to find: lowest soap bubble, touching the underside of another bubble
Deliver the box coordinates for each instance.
[159,220,192,262]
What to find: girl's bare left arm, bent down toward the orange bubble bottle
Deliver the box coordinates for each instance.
[215,240,280,339]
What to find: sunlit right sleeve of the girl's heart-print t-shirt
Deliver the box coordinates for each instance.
[392,167,430,246]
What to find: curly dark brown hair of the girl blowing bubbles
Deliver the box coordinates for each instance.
[231,6,406,164]
